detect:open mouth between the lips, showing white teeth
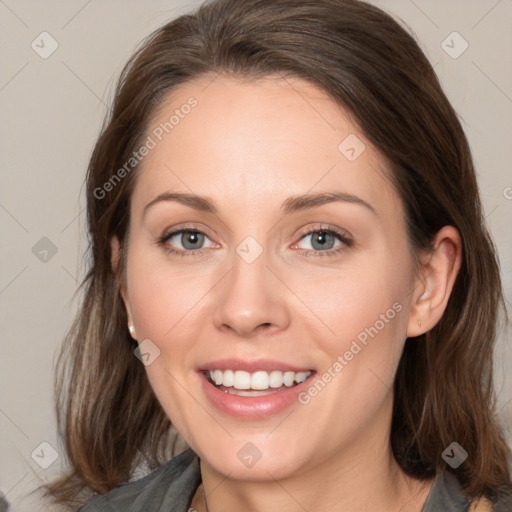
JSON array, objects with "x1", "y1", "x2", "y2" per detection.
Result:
[{"x1": 204, "y1": 370, "x2": 315, "y2": 397}]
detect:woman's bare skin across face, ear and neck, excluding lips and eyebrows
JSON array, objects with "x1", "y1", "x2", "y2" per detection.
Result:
[{"x1": 112, "y1": 76, "x2": 461, "y2": 512}]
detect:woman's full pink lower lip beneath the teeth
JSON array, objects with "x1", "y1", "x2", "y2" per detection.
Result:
[{"x1": 198, "y1": 371, "x2": 314, "y2": 419}]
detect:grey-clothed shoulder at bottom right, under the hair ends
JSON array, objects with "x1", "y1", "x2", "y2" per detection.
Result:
[{"x1": 422, "y1": 471, "x2": 512, "y2": 512}]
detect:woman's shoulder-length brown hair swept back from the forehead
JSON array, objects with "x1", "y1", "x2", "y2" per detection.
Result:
[{"x1": 47, "y1": 0, "x2": 512, "y2": 506}]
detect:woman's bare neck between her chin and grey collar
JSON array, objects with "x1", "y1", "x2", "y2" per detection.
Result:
[{"x1": 196, "y1": 434, "x2": 432, "y2": 512}]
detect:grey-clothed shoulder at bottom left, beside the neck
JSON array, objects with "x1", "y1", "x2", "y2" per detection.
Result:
[{"x1": 77, "y1": 449, "x2": 201, "y2": 512}]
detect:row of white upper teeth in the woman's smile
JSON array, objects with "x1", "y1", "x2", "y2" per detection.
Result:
[{"x1": 205, "y1": 370, "x2": 311, "y2": 391}]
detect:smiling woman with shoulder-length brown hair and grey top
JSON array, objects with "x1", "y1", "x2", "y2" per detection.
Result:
[{"x1": 43, "y1": 0, "x2": 512, "y2": 512}]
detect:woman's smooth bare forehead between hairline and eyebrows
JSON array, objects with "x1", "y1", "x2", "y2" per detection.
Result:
[{"x1": 133, "y1": 75, "x2": 398, "y2": 220}]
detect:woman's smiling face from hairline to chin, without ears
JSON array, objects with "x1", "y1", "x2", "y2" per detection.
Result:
[{"x1": 123, "y1": 77, "x2": 415, "y2": 480}]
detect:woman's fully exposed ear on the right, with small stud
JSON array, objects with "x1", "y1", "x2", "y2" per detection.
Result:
[{"x1": 407, "y1": 226, "x2": 462, "y2": 337}]
